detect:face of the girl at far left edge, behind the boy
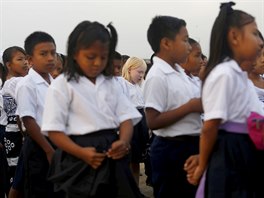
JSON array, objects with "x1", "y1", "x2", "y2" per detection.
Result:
[{"x1": 8, "y1": 51, "x2": 29, "y2": 76}]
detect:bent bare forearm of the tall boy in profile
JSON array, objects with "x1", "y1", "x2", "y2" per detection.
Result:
[{"x1": 146, "y1": 98, "x2": 202, "y2": 130}]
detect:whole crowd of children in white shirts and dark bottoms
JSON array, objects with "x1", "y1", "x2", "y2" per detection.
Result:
[{"x1": 0, "y1": 2, "x2": 264, "y2": 198}]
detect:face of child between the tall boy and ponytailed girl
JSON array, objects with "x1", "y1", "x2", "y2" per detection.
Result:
[{"x1": 186, "y1": 43, "x2": 203, "y2": 76}]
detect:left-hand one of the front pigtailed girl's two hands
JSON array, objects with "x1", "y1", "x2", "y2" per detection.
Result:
[{"x1": 81, "y1": 147, "x2": 106, "y2": 169}]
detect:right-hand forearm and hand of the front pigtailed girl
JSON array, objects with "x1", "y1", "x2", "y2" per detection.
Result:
[{"x1": 107, "y1": 120, "x2": 133, "y2": 159}]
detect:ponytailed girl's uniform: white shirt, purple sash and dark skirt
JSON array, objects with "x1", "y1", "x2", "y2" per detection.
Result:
[{"x1": 199, "y1": 59, "x2": 263, "y2": 198}]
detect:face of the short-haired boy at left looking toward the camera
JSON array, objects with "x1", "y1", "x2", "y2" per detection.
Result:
[{"x1": 28, "y1": 42, "x2": 56, "y2": 74}]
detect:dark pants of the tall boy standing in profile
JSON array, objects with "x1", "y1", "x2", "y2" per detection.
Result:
[{"x1": 150, "y1": 136, "x2": 199, "y2": 198}]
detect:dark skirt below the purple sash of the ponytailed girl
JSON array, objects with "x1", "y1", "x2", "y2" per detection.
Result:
[{"x1": 205, "y1": 130, "x2": 258, "y2": 198}]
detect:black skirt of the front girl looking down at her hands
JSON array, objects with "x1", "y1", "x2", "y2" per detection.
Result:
[{"x1": 49, "y1": 130, "x2": 142, "y2": 198}]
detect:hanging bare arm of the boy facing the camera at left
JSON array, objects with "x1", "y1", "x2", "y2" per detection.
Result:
[{"x1": 22, "y1": 116, "x2": 54, "y2": 162}]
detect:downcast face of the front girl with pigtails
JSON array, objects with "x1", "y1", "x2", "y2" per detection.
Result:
[{"x1": 74, "y1": 41, "x2": 109, "y2": 83}]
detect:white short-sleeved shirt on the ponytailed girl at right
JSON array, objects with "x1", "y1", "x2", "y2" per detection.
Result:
[{"x1": 202, "y1": 60, "x2": 263, "y2": 123}]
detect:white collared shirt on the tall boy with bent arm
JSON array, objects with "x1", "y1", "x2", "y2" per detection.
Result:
[{"x1": 143, "y1": 57, "x2": 202, "y2": 137}]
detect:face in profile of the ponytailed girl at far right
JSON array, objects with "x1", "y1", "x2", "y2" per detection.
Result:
[{"x1": 235, "y1": 22, "x2": 263, "y2": 62}]
